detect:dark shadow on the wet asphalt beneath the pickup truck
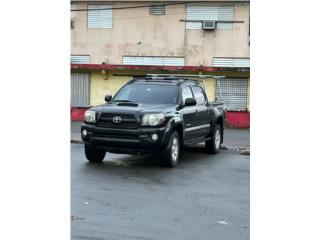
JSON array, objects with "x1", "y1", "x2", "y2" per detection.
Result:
[{"x1": 77, "y1": 146, "x2": 225, "y2": 185}]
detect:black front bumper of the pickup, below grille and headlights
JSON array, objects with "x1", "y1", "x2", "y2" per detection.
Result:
[{"x1": 81, "y1": 123, "x2": 169, "y2": 154}]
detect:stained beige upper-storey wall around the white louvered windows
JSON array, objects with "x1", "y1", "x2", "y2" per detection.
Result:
[{"x1": 71, "y1": 2, "x2": 249, "y2": 66}]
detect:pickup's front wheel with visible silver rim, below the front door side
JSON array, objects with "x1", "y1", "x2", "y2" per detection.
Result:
[{"x1": 161, "y1": 131, "x2": 181, "y2": 168}]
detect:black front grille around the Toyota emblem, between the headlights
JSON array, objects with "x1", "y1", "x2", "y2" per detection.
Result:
[{"x1": 97, "y1": 113, "x2": 138, "y2": 129}]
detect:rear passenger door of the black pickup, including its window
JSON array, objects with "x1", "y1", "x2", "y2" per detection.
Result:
[{"x1": 192, "y1": 86, "x2": 210, "y2": 137}]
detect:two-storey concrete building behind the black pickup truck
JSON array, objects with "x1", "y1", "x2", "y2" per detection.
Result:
[{"x1": 71, "y1": 0, "x2": 250, "y2": 127}]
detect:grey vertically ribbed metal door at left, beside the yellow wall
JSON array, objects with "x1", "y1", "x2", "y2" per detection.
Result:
[{"x1": 71, "y1": 73, "x2": 90, "y2": 107}]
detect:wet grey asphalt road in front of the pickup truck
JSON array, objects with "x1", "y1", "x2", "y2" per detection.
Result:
[{"x1": 71, "y1": 144, "x2": 250, "y2": 240}]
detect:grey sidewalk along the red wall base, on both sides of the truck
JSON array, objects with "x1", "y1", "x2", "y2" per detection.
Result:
[{"x1": 71, "y1": 121, "x2": 250, "y2": 149}]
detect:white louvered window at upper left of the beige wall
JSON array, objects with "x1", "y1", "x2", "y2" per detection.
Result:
[{"x1": 88, "y1": 5, "x2": 112, "y2": 28}]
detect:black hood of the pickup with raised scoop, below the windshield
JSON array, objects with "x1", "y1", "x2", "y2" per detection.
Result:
[{"x1": 90, "y1": 103, "x2": 178, "y2": 115}]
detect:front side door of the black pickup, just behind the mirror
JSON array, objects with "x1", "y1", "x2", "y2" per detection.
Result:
[{"x1": 181, "y1": 86, "x2": 197, "y2": 140}]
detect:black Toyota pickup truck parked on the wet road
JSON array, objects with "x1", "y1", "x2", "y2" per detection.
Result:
[{"x1": 81, "y1": 77, "x2": 225, "y2": 167}]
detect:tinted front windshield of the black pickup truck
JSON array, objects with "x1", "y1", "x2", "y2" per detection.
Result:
[{"x1": 113, "y1": 83, "x2": 178, "y2": 104}]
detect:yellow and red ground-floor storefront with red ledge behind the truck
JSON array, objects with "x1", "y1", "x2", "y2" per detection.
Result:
[{"x1": 71, "y1": 64, "x2": 250, "y2": 128}]
